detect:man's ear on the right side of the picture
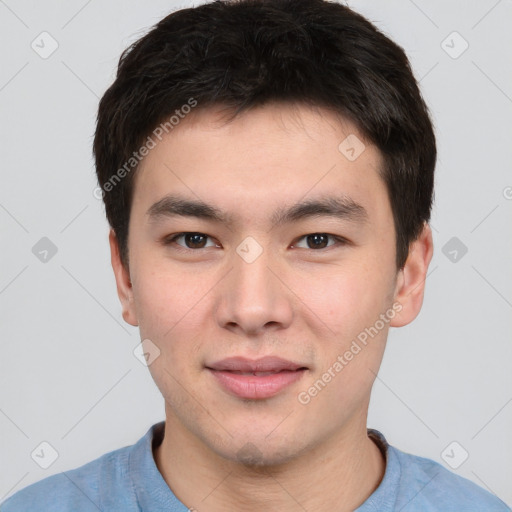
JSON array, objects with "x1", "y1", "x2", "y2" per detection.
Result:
[{"x1": 390, "y1": 223, "x2": 433, "y2": 327}]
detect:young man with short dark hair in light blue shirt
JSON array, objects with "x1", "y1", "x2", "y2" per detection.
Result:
[{"x1": 2, "y1": 0, "x2": 509, "y2": 512}]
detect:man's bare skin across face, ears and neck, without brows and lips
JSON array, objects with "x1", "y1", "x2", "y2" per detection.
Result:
[{"x1": 110, "y1": 104, "x2": 432, "y2": 512}]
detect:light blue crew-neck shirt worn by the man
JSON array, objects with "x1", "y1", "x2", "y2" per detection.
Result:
[{"x1": 0, "y1": 422, "x2": 511, "y2": 512}]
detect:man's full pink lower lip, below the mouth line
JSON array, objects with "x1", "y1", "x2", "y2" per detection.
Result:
[{"x1": 209, "y1": 368, "x2": 306, "y2": 400}]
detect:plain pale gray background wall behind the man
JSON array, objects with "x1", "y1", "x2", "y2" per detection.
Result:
[{"x1": 0, "y1": 0, "x2": 512, "y2": 505}]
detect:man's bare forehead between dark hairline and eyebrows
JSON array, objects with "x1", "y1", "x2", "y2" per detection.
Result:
[{"x1": 129, "y1": 104, "x2": 387, "y2": 226}]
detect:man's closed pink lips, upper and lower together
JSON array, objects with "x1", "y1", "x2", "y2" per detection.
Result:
[{"x1": 206, "y1": 356, "x2": 307, "y2": 400}]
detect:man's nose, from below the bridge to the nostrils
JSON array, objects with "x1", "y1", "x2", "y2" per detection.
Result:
[{"x1": 216, "y1": 242, "x2": 294, "y2": 337}]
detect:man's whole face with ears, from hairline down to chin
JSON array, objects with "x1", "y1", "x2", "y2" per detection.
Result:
[{"x1": 111, "y1": 105, "x2": 430, "y2": 464}]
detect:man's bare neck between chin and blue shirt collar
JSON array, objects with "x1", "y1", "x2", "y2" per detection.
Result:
[{"x1": 154, "y1": 415, "x2": 386, "y2": 512}]
